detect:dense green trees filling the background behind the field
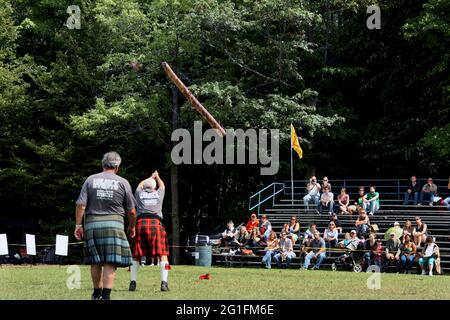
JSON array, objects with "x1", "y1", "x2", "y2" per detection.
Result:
[{"x1": 0, "y1": 0, "x2": 450, "y2": 255}]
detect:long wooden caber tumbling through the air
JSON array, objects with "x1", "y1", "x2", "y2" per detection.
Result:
[{"x1": 161, "y1": 62, "x2": 226, "y2": 137}]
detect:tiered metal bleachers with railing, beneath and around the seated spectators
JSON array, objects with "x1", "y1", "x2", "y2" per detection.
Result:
[{"x1": 213, "y1": 179, "x2": 450, "y2": 273}]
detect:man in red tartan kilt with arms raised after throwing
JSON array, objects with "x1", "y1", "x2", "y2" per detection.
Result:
[{"x1": 129, "y1": 171, "x2": 170, "y2": 291}]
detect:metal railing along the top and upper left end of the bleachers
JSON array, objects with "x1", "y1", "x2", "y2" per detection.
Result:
[{"x1": 249, "y1": 178, "x2": 450, "y2": 214}]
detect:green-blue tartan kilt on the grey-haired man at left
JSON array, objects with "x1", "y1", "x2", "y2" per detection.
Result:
[{"x1": 84, "y1": 215, "x2": 132, "y2": 267}]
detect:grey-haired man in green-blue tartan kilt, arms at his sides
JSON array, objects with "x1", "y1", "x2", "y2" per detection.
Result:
[{"x1": 74, "y1": 152, "x2": 136, "y2": 300}]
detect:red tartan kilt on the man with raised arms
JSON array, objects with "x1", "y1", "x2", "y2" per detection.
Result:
[{"x1": 132, "y1": 218, "x2": 169, "y2": 261}]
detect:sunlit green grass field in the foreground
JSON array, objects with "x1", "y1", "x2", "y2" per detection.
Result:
[{"x1": 0, "y1": 266, "x2": 450, "y2": 300}]
